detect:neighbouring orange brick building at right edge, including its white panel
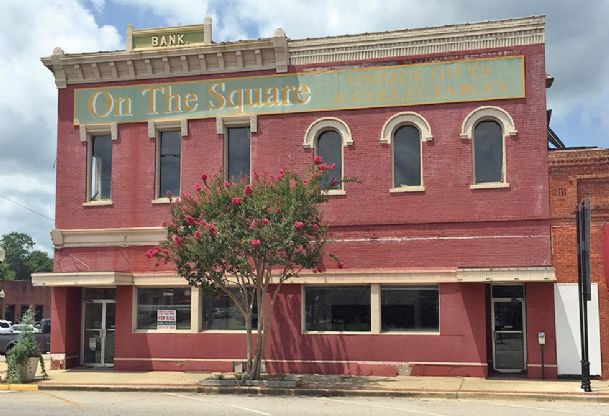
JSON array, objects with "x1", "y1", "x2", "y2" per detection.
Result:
[{"x1": 549, "y1": 148, "x2": 609, "y2": 377}]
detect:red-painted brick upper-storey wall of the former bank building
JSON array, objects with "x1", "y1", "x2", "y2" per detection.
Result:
[{"x1": 55, "y1": 44, "x2": 550, "y2": 272}]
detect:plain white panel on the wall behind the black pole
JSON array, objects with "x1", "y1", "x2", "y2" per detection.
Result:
[{"x1": 554, "y1": 283, "x2": 601, "y2": 376}]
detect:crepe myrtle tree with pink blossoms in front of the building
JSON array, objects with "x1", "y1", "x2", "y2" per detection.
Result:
[{"x1": 147, "y1": 157, "x2": 344, "y2": 380}]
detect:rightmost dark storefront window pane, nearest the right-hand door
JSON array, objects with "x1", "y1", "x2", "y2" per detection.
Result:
[{"x1": 381, "y1": 286, "x2": 439, "y2": 331}]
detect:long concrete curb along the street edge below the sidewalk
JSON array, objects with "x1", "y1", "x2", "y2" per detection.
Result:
[{"x1": 35, "y1": 384, "x2": 609, "y2": 403}]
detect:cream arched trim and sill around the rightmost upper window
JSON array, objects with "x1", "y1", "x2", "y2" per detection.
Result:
[{"x1": 461, "y1": 106, "x2": 518, "y2": 190}]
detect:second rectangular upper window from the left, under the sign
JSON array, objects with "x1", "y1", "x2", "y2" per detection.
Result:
[{"x1": 156, "y1": 130, "x2": 182, "y2": 198}]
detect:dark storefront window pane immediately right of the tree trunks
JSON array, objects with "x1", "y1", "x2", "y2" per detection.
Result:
[{"x1": 305, "y1": 286, "x2": 370, "y2": 331}]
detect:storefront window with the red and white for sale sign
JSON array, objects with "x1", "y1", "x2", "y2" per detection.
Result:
[{"x1": 137, "y1": 288, "x2": 190, "y2": 329}]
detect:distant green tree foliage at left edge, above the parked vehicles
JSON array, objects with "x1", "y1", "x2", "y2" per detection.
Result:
[{"x1": 0, "y1": 232, "x2": 53, "y2": 280}]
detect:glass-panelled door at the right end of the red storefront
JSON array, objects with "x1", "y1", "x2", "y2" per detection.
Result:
[{"x1": 491, "y1": 285, "x2": 526, "y2": 373}]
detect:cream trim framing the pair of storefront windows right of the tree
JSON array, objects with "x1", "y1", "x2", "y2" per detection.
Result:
[{"x1": 300, "y1": 283, "x2": 442, "y2": 336}]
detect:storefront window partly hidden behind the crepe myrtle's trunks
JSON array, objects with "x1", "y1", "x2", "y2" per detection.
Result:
[{"x1": 203, "y1": 288, "x2": 258, "y2": 330}]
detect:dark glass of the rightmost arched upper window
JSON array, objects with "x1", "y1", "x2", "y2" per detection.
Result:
[{"x1": 473, "y1": 120, "x2": 505, "y2": 184}]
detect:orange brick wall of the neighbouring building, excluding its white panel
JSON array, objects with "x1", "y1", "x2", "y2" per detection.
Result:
[{"x1": 549, "y1": 149, "x2": 609, "y2": 378}]
